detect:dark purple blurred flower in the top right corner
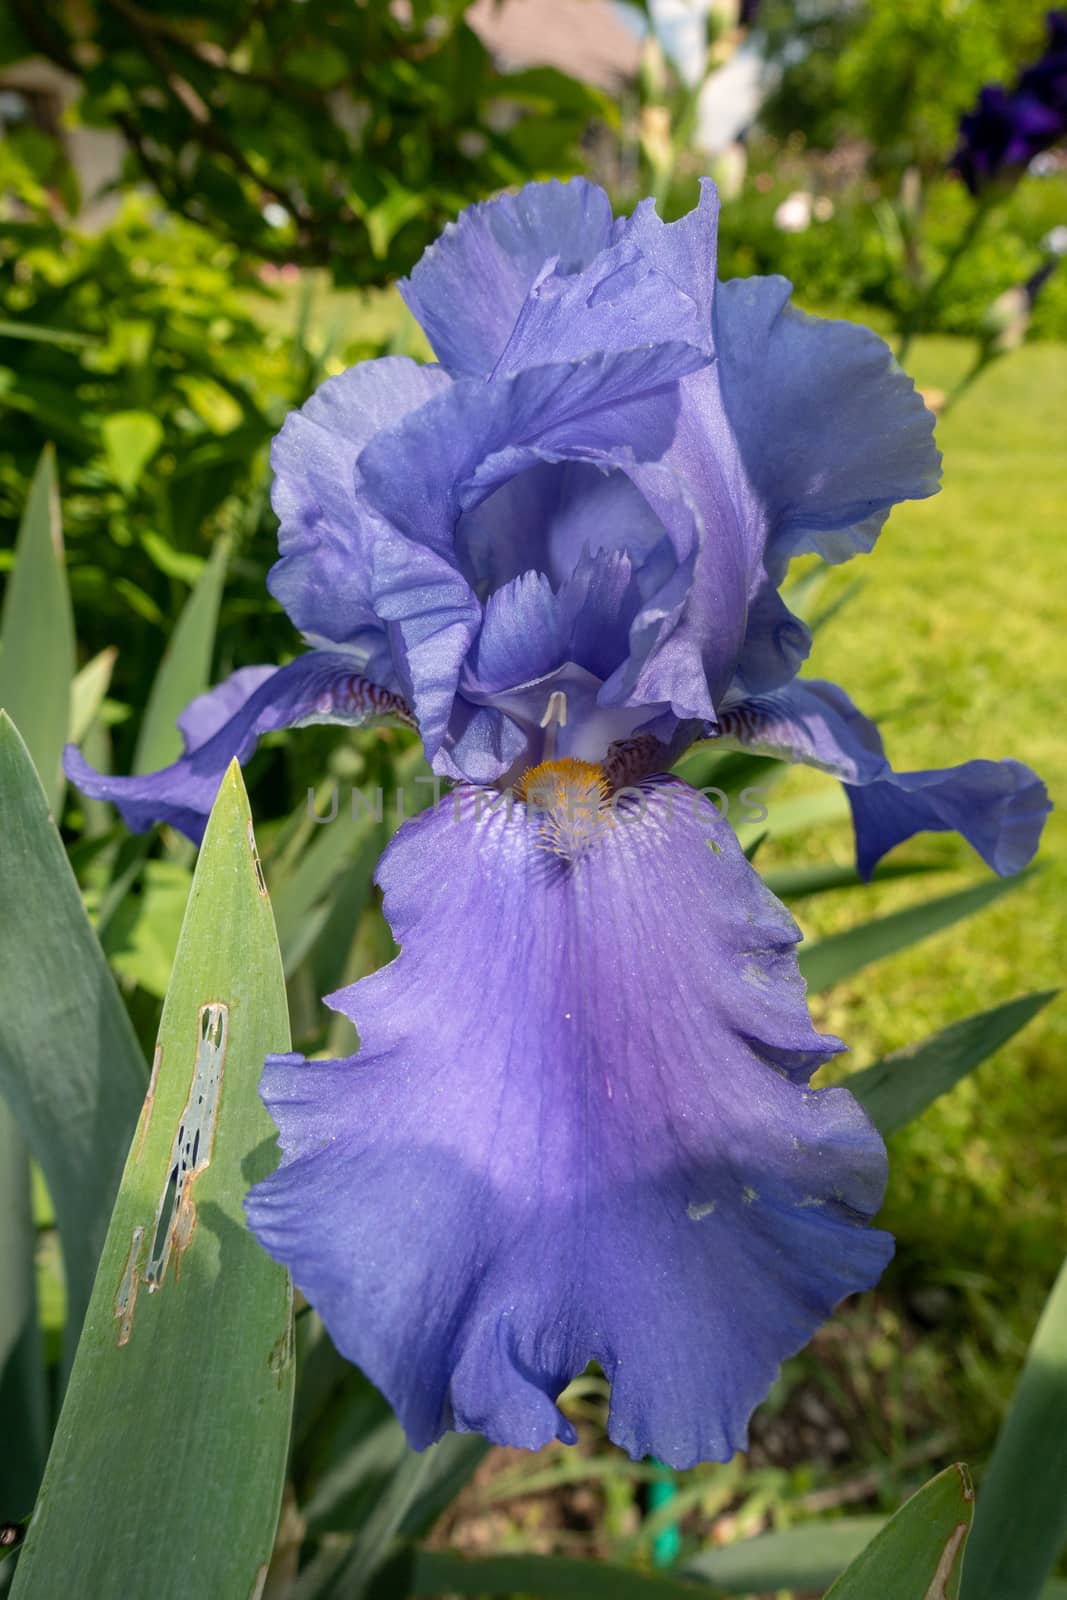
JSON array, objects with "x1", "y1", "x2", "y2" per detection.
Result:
[{"x1": 952, "y1": 11, "x2": 1067, "y2": 195}]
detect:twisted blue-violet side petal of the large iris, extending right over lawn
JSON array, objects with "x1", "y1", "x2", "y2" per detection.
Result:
[{"x1": 718, "y1": 678, "x2": 1051, "y2": 878}]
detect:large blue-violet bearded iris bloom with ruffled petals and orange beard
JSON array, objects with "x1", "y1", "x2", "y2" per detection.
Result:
[{"x1": 67, "y1": 181, "x2": 1048, "y2": 1467}]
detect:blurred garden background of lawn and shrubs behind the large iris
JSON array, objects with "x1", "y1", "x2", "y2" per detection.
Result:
[{"x1": 0, "y1": 0, "x2": 1067, "y2": 1587}]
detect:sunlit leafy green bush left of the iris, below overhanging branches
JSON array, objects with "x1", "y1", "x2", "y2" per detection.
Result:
[{"x1": 0, "y1": 197, "x2": 300, "y2": 729}]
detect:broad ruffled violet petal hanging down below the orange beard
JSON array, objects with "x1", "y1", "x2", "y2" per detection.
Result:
[{"x1": 246, "y1": 779, "x2": 891, "y2": 1467}]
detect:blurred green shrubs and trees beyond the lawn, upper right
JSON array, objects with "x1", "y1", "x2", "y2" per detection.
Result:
[{"x1": 627, "y1": 0, "x2": 1067, "y2": 344}]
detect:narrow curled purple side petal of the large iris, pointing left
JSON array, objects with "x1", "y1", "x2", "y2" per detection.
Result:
[{"x1": 62, "y1": 650, "x2": 410, "y2": 843}]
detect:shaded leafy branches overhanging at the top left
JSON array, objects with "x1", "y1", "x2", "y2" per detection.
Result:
[{"x1": 0, "y1": 0, "x2": 613, "y2": 283}]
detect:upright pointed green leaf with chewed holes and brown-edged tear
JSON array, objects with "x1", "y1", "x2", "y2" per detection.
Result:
[{"x1": 13, "y1": 765, "x2": 293, "y2": 1600}]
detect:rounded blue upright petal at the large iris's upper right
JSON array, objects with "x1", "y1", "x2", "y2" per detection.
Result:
[{"x1": 709, "y1": 278, "x2": 941, "y2": 584}]
